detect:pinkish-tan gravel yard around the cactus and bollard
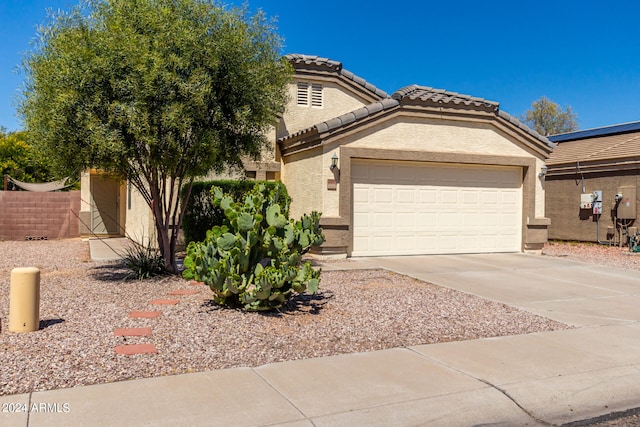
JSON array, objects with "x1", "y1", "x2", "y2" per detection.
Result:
[{"x1": 0, "y1": 239, "x2": 567, "y2": 395}]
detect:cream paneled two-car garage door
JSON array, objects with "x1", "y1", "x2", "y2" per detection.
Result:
[{"x1": 351, "y1": 160, "x2": 522, "y2": 256}]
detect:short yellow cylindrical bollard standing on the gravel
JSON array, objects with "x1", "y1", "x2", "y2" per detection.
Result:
[{"x1": 9, "y1": 267, "x2": 40, "y2": 332}]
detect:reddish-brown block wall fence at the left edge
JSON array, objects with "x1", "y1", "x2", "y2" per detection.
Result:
[{"x1": 0, "y1": 191, "x2": 80, "y2": 240}]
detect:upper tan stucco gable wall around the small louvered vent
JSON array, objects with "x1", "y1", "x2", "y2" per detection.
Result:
[{"x1": 277, "y1": 78, "x2": 368, "y2": 138}]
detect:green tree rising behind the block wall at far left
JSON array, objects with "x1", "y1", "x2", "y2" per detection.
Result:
[{"x1": 0, "y1": 127, "x2": 53, "y2": 186}]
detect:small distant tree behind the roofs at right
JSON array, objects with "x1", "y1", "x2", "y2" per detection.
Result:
[{"x1": 522, "y1": 96, "x2": 578, "y2": 136}]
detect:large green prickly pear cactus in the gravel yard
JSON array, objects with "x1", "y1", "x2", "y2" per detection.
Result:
[{"x1": 183, "y1": 184, "x2": 324, "y2": 311}]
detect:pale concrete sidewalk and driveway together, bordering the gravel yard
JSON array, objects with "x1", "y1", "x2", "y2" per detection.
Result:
[{"x1": 0, "y1": 254, "x2": 640, "y2": 426}]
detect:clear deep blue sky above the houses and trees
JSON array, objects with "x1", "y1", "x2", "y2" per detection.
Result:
[{"x1": 0, "y1": 0, "x2": 640, "y2": 130}]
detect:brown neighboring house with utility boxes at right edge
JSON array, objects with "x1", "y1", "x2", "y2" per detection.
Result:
[{"x1": 545, "y1": 122, "x2": 640, "y2": 243}]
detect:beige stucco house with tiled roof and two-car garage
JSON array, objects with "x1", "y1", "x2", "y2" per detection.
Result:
[{"x1": 84, "y1": 54, "x2": 553, "y2": 256}]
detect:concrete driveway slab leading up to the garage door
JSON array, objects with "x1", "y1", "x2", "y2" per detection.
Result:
[{"x1": 353, "y1": 253, "x2": 640, "y2": 327}]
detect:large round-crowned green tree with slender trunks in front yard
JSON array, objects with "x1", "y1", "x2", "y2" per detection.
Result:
[{"x1": 20, "y1": 0, "x2": 291, "y2": 272}]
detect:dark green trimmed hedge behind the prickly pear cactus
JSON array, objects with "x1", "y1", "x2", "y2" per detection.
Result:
[{"x1": 182, "y1": 180, "x2": 291, "y2": 245}]
